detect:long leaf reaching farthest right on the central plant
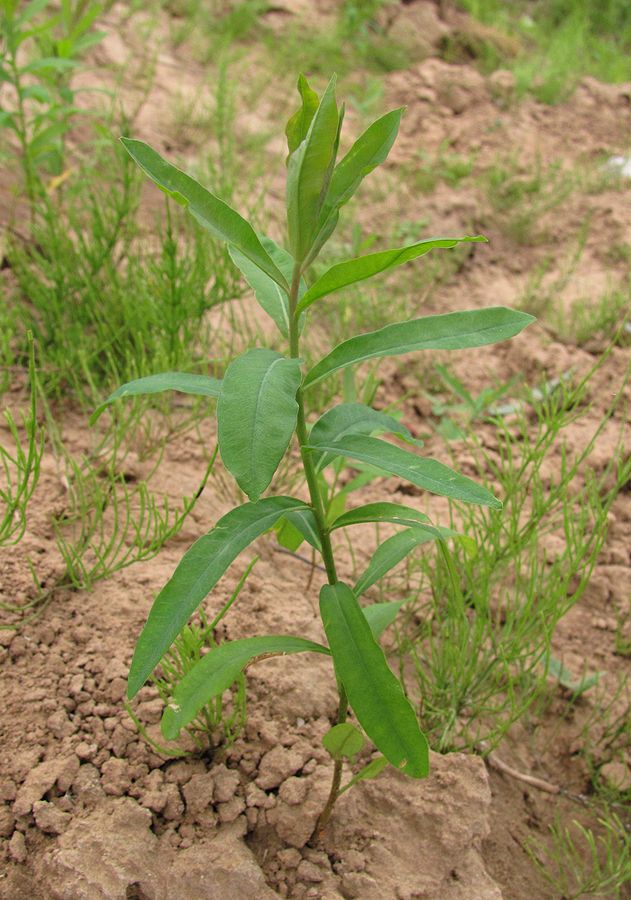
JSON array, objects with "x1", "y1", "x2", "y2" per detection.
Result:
[{"x1": 303, "y1": 306, "x2": 535, "y2": 388}]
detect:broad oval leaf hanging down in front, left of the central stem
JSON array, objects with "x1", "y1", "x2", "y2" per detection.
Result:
[{"x1": 217, "y1": 348, "x2": 301, "y2": 500}]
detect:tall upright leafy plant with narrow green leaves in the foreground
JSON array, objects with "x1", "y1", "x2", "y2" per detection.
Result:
[{"x1": 96, "y1": 77, "x2": 532, "y2": 828}]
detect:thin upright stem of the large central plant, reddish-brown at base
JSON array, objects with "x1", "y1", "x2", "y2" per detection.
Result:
[{"x1": 289, "y1": 263, "x2": 348, "y2": 838}]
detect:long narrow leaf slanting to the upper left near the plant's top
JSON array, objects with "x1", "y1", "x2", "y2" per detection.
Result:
[{"x1": 121, "y1": 138, "x2": 289, "y2": 290}]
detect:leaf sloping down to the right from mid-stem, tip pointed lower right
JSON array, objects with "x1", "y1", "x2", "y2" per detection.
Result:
[{"x1": 308, "y1": 434, "x2": 502, "y2": 509}]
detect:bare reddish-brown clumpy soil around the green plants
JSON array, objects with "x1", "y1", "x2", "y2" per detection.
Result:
[{"x1": 0, "y1": 4, "x2": 631, "y2": 900}]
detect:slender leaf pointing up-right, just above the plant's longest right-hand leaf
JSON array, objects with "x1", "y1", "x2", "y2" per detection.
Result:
[{"x1": 297, "y1": 235, "x2": 486, "y2": 312}]
